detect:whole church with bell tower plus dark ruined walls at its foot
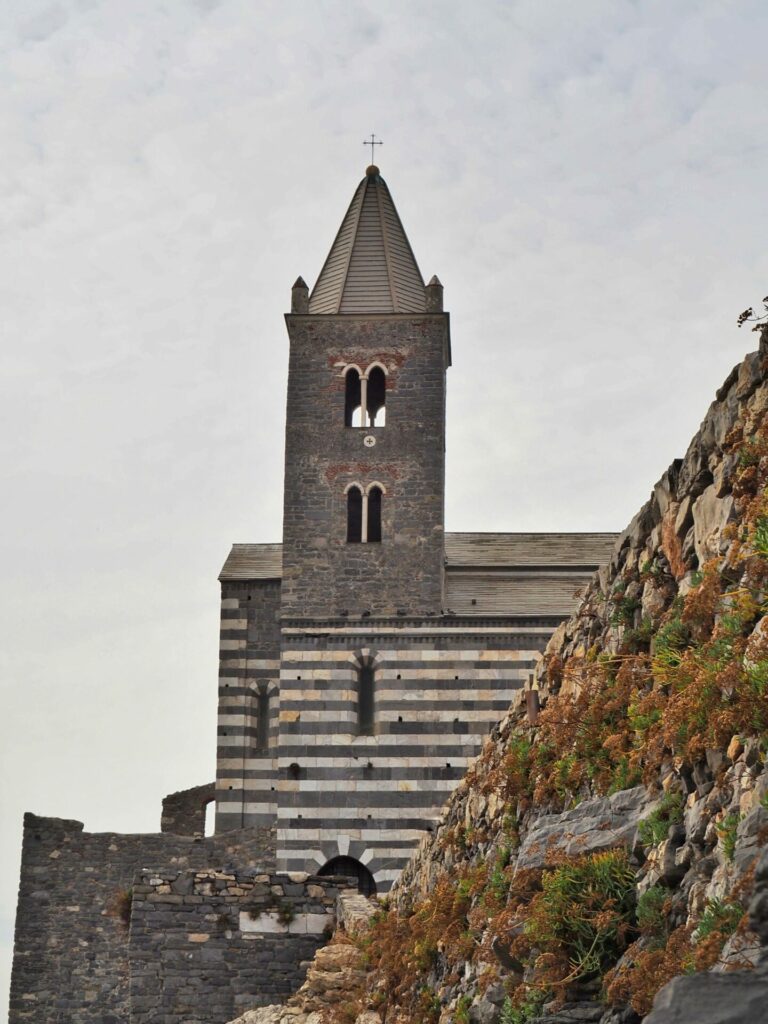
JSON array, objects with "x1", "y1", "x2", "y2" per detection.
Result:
[{"x1": 9, "y1": 166, "x2": 615, "y2": 1024}]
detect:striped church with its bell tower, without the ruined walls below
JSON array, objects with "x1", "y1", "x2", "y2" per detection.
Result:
[{"x1": 211, "y1": 166, "x2": 614, "y2": 892}]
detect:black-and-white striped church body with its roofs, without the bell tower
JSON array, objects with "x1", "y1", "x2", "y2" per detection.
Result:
[{"x1": 211, "y1": 534, "x2": 613, "y2": 892}]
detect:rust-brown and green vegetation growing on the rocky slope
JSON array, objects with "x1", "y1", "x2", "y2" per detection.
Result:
[{"x1": 339, "y1": 399, "x2": 768, "y2": 1024}]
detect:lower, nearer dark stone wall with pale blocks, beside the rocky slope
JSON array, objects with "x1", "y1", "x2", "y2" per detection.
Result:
[{"x1": 130, "y1": 870, "x2": 356, "y2": 1024}]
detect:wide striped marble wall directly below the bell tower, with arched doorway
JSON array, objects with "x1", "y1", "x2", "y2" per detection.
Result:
[{"x1": 278, "y1": 621, "x2": 552, "y2": 891}]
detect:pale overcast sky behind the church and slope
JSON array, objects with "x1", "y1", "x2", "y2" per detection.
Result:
[{"x1": 0, "y1": 0, "x2": 768, "y2": 1005}]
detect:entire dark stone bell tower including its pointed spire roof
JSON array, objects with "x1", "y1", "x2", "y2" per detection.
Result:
[{"x1": 282, "y1": 166, "x2": 451, "y2": 618}]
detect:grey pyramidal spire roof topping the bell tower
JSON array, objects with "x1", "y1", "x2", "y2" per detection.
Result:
[{"x1": 309, "y1": 166, "x2": 426, "y2": 313}]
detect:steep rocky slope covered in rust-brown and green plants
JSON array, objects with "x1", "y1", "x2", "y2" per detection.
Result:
[{"x1": 230, "y1": 332, "x2": 768, "y2": 1024}]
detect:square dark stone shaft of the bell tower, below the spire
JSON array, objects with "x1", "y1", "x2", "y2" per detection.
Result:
[{"x1": 283, "y1": 313, "x2": 447, "y2": 616}]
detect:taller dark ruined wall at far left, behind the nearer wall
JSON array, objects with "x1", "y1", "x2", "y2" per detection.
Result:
[{"x1": 9, "y1": 814, "x2": 273, "y2": 1024}]
